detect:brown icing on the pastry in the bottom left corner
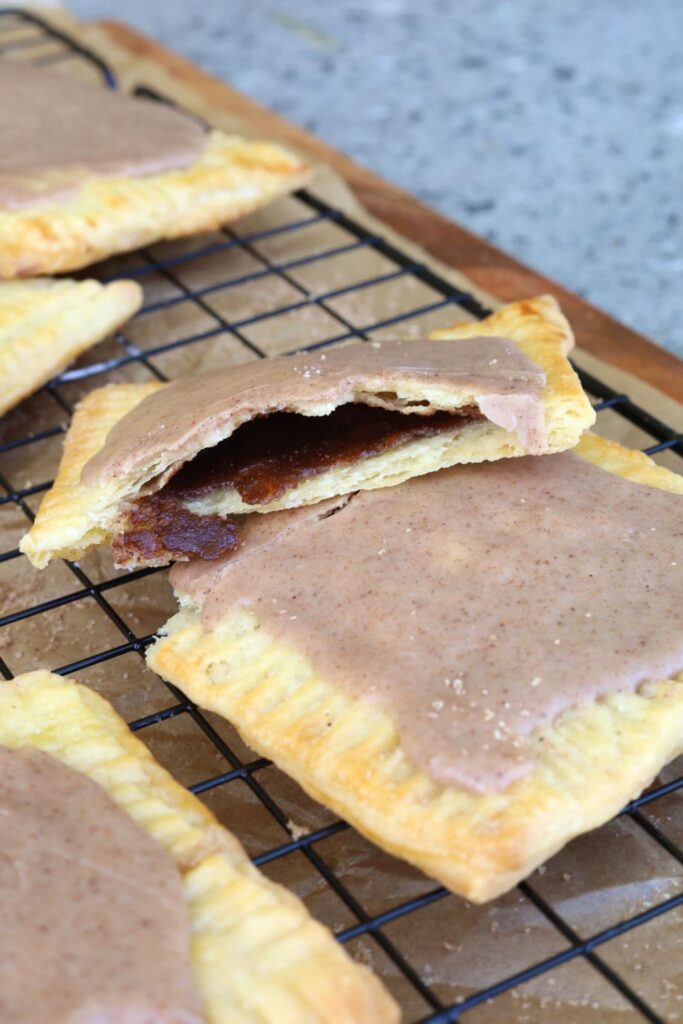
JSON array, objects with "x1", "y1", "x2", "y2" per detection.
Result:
[{"x1": 0, "y1": 746, "x2": 204, "y2": 1024}]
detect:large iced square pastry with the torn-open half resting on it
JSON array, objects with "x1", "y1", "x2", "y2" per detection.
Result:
[{"x1": 147, "y1": 434, "x2": 683, "y2": 902}]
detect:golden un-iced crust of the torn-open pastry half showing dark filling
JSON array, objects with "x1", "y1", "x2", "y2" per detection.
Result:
[{"x1": 22, "y1": 296, "x2": 595, "y2": 568}]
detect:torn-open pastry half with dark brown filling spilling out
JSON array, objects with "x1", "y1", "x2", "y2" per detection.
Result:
[{"x1": 22, "y1": 297, "x2": 595, "y2": 567}]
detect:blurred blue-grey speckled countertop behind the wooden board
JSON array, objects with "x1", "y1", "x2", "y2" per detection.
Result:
[{"x1": 69, "y1": 0, "x2": 683, "y2": 354}]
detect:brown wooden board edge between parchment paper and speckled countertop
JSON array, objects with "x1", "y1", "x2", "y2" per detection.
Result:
[{"x1": 98, "y1": 20, "x2": 683, "y2": 401}]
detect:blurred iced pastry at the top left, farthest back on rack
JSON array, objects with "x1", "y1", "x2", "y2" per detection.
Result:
[{"x1": 0, "y1": 60, "x2": 309, "y2": 278}]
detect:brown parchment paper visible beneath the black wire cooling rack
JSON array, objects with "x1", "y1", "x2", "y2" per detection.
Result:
[{"x1": 0, "y1": 10, "x2": 683, "y2": 1024}]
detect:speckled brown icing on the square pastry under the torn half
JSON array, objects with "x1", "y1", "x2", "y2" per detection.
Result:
[{"x1": 173, "y1": 453, "x2": 683, "y2": 791}]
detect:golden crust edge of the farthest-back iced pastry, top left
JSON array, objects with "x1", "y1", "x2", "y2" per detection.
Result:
[{"x1": 0, "y1": 131, "x2": 310, "y2": 279}]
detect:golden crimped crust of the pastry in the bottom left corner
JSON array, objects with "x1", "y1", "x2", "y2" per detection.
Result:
[{"x1": 0, "y1": 672, "x2": 399, "y2": 1024}]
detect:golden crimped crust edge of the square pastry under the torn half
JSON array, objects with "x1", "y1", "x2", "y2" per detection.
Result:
[{"x1": 147, "y1": 436, "x2": 683, "y2": 902}]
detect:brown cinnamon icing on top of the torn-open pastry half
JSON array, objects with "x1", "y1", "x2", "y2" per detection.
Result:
[{"x1": 81, "y1": 337, "x2": 546, "y2": 485}]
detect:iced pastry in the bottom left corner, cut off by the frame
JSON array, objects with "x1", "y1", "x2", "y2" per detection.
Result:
[{"x1": 0, "y1": 672, "x2": 399, "y2": 1024}]
